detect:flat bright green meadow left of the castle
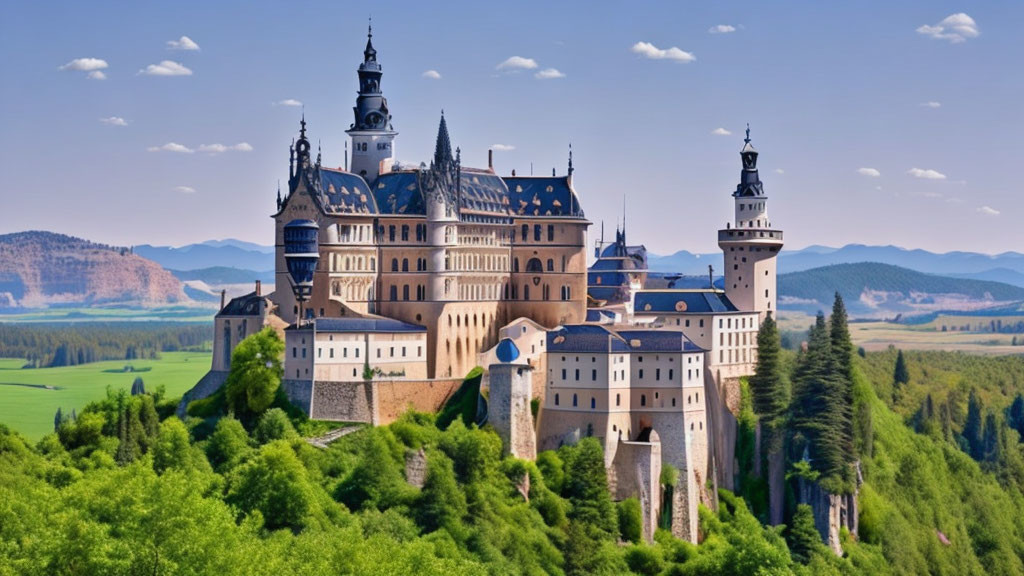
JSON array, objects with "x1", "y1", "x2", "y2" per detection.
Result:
[{"x1": 0, "y1": 352, "x2": 211, "y2": 440}]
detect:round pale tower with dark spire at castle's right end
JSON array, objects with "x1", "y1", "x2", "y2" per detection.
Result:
[{"x1": 718, "y1": 126, "x2": 782, "y2": 320}]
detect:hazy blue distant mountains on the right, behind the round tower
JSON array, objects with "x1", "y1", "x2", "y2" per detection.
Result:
[{"x1": 648, "y1": 244, "x2": 1024, "y2": 287}]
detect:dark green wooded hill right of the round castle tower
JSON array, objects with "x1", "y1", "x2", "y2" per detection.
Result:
[{"x1": 778, "y1": 262, "x2": 1024, "y2": 316}]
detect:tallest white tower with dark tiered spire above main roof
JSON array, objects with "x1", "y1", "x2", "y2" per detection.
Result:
[{"x1": 345, "y1": 21, "x2": 398, "y2": 182}]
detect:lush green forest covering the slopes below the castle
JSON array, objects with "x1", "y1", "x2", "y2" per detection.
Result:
[{"x1": 0, "y1": 317, "x2": 1024, "y2": 575}]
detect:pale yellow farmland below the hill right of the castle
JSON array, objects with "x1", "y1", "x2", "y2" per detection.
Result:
[{"x1": 779, "y1": 313, "x2": 1024, "y2": 356}]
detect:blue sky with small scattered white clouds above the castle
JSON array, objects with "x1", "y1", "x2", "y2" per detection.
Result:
[{"x1": 0, "y1": 1, "x2": 1024, "y2": 253}]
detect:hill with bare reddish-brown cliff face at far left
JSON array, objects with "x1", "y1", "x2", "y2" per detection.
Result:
[{"x1": 0, "y1": 232, "x2": 188, "y2": 311}]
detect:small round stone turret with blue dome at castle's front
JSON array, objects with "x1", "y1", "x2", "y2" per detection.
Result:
[{"x1": 487, "y1": 338, "x2": 537, "y2": 460}]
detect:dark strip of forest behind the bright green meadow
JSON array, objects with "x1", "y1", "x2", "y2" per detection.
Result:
[{"x1": 0, "y1": 322, "x2": 213, "y2": 368}]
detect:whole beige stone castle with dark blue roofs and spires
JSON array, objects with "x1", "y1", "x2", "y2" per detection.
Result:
[{"x1": 182, "y1": 25, "x2": 782, "y2": 540}]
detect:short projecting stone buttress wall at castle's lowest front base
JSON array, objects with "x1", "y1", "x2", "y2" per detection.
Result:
[{"x1": 608, "y1": 430, "x2": 662, "y2": 542}]
